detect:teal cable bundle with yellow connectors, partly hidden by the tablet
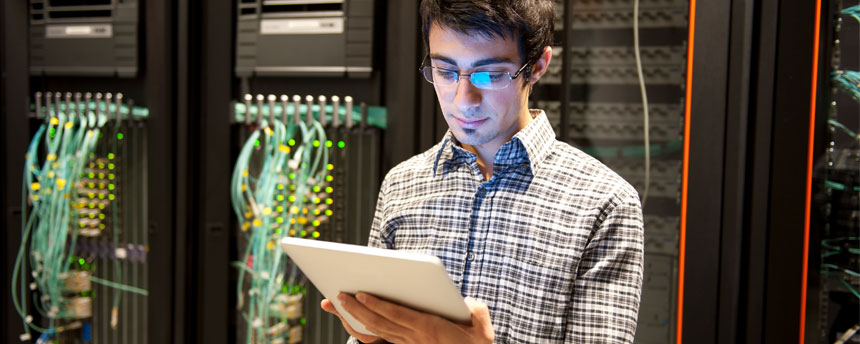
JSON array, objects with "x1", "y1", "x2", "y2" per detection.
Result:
[{"x1": 230, "y1": 94, "x2": 352, "y2": 343}]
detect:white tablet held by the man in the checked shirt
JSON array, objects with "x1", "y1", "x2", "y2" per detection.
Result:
[{"x1": 281, "y1": 238, "x2": 472, "y2": 335}]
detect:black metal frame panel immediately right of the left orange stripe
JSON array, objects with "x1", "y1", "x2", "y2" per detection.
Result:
[{"x1": 682, "y1": 1, "x2": 735, "y2": 342}]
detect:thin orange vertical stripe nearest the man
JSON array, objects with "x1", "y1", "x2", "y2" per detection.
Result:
[{"x1": 675, "y1": 0, "x2": 696, "y2": 344}]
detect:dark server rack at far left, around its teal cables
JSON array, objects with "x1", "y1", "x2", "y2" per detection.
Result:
[{"x1": 0, "y1": 1, "x2": 185, "y2": 343}]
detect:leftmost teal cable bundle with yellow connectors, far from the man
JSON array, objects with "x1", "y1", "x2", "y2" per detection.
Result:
[{"x1": 12, "y1": 93, "x2": 146, "y2": 341}]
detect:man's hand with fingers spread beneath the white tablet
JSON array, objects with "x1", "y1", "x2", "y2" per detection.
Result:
[{"x1": 321, "y1": 293, "x2": 494, "y2": 344}]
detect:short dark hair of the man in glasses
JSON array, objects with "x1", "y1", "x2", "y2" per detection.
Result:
[{"x1": 421, "y1": 0, "x2": 555, "y2": 78}]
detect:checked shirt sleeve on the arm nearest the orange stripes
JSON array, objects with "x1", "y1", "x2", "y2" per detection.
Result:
[{"x1": 565, "y1": 191, "x2": 645, "y2": 343}]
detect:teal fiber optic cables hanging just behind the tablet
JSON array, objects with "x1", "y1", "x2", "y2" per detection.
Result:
[{"x1": 230, "y1": 97, "x2": 340, "y2": 343}]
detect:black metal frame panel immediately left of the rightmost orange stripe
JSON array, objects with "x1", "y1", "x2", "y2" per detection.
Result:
[{"x1": 740, "y1": 0, "x2": 826, "y2": 343}]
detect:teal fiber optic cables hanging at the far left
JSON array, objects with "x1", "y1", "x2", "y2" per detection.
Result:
[{"x1": 12, "y1": 93, "x2": 146, "y2": 338}]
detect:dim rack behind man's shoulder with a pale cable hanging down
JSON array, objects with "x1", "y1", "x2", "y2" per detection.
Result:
[{"x1": 530, "y1": 0, "x2": 689, "y2": 343}]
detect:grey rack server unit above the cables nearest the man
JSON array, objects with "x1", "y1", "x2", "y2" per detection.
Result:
[{"x1": 236, "y1": 0, "x2": 374, "y2": 78}]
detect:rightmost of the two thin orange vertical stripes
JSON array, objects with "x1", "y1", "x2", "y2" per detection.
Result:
[{"x1": 799, "y1": 0, "x2": 821, "y2": 344}]
